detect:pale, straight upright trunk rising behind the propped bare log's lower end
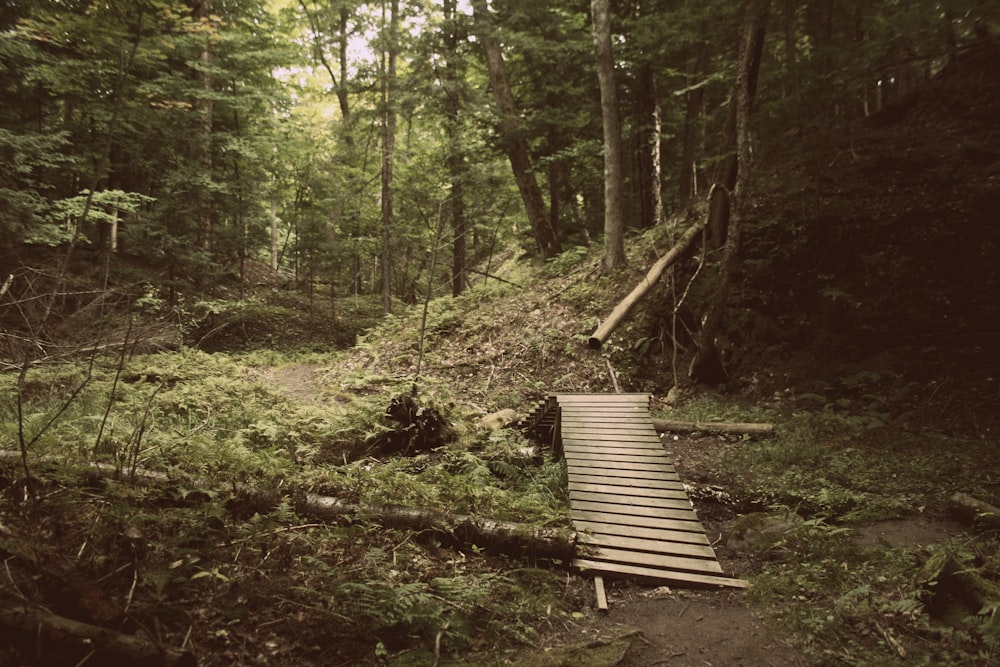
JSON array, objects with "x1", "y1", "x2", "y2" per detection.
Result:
[{"x1": 590, "y1": 0, "x2": 625, "y2": 271}]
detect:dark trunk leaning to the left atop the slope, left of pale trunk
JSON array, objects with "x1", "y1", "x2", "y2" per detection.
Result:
[{"x1": 472, "y1": 0, "x2": 562, "y2": 259}]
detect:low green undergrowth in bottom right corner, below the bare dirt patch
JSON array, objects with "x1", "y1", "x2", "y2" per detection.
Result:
[{"x1": 748, "y1": 518, "x2": 1000, "y2": 666}]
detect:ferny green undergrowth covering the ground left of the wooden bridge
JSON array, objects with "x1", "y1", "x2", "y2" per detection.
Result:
[{"x1": 0, "y1": 350, "x2": 573, "y2": 664}]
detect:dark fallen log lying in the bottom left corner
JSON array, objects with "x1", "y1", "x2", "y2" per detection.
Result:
[{"x1": 0, "y1": 602, "x2": 198, "y2": 667}]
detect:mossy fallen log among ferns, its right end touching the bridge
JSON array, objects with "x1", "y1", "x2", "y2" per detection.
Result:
[{"x1": 295, "y1": 494, "x2": 576, "y2": 562}]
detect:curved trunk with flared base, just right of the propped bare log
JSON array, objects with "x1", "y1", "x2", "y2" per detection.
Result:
[{"x1": 688, "y1": 0, "x2": 770, "y2": 384}]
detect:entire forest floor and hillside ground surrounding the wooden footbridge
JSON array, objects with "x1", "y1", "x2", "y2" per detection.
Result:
[{"x1": 0, "y1": 37, "x2": 1000, "y2": 667}]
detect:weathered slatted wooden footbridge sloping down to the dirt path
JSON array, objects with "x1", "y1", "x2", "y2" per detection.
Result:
[{"x1": 527, "y1": 394, "x2": 747, "y2": 597}]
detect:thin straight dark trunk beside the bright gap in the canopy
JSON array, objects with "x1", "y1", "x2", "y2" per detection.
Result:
[{"x1": 381, "y1": 0, "x2": 399, "y2": 313}]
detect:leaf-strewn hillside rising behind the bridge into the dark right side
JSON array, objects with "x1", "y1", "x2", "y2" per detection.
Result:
[{"x1": 331, "y1": 43, "x2": 1000, "y2": 438}]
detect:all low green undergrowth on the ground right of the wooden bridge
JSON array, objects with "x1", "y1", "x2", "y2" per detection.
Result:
[{"x1": 669, "y1": 392, "x2": 1000, "y2": 665}]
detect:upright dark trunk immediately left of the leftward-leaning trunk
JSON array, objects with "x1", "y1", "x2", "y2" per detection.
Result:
[{"x1": 444, "y1": 0, "x2": 468, "y2": 296}]
